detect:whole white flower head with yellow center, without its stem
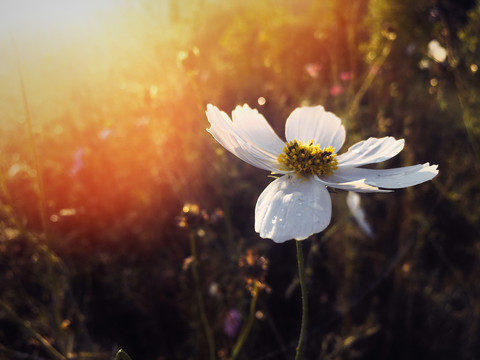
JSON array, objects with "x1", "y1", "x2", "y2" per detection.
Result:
[{"x1": 206, "y1": 105, "x2": 438, "y2": 243}]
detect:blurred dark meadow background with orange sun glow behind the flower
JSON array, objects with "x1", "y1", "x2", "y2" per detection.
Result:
[{"x1": 0, "y1": 0, "x2": 480, "y2": 360}]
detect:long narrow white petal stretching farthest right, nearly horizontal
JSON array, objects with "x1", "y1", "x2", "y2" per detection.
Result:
[{"x1": 334, "y1": 163, "x2": 438, "y2": 189}]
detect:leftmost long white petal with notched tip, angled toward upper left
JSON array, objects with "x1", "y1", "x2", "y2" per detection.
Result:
[{"x1": 206, "y1": 104, "x2": 285, "y2": 173}]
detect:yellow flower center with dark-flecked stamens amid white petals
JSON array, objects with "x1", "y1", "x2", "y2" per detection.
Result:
[{"x1": 278, "y1": 139, "x2": 338, "y2": 177}]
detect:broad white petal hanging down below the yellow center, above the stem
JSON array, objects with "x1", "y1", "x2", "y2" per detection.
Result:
[{"x1": 255, "y1": 174, "x2": 332, "y2": 243}]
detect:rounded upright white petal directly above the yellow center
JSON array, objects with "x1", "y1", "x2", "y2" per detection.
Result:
[{"x1": 285, "y1": 106, "x2": 345, "y2": 152}]
